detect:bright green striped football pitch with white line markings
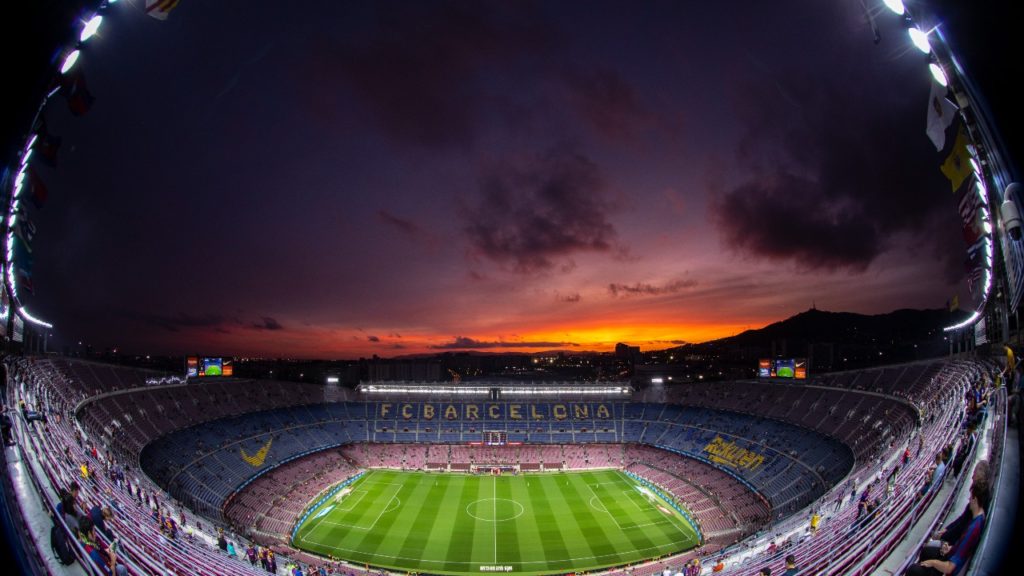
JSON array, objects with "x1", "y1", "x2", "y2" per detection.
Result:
[{"x1": 293, "y1": 470, "x2": 697, "y2": 574}]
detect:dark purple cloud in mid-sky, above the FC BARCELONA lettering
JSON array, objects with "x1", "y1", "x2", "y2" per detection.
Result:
[{"x1": 463, "y1": 151, "x2": 620, "y2": 274}]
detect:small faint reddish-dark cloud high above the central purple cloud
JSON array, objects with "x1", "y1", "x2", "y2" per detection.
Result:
[{"x1": 565, "y1": 69, "x2": 650, "y2": 139}]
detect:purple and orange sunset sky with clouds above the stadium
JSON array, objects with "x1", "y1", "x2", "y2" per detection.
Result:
[{"x1": 27, "y1": 0, "x2": 999, "y2": 358}]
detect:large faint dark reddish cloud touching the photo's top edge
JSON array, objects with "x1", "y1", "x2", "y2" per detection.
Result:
[{"x1": 329, "y1": 1, "x2": 552, "y2": 147}]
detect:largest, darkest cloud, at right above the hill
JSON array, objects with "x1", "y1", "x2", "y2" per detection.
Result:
[{"x1": 711, "y1": 50, "x2": 951, "y2": 272}]
